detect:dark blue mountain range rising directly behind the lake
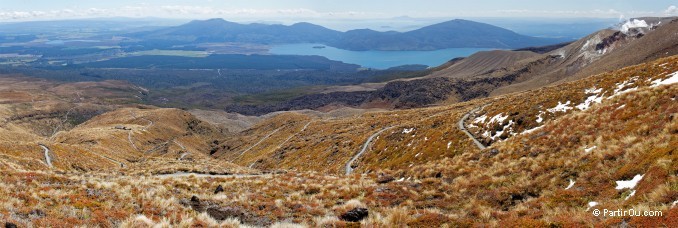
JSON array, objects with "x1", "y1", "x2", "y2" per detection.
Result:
[{"x1": 132, "y1": 19, "x2": 566, "y2": 51}]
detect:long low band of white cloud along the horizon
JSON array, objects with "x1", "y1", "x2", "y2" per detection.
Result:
[{"x1": 0, "y1": 3, "x2": 678, "y2": 21}]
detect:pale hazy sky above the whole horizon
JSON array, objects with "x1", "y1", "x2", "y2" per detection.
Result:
[{"x1": 0, "y1": 0, "x2": 678, "y2": 22}]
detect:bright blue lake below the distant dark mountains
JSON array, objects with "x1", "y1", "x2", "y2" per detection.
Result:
[{"x1": 269, "y1": 44, "x2": 491, "y2": 69}]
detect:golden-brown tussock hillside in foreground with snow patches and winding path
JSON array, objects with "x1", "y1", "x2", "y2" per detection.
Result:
[{"x1": 0, "y1": 56, "x2": 678, "y2": 227}]
